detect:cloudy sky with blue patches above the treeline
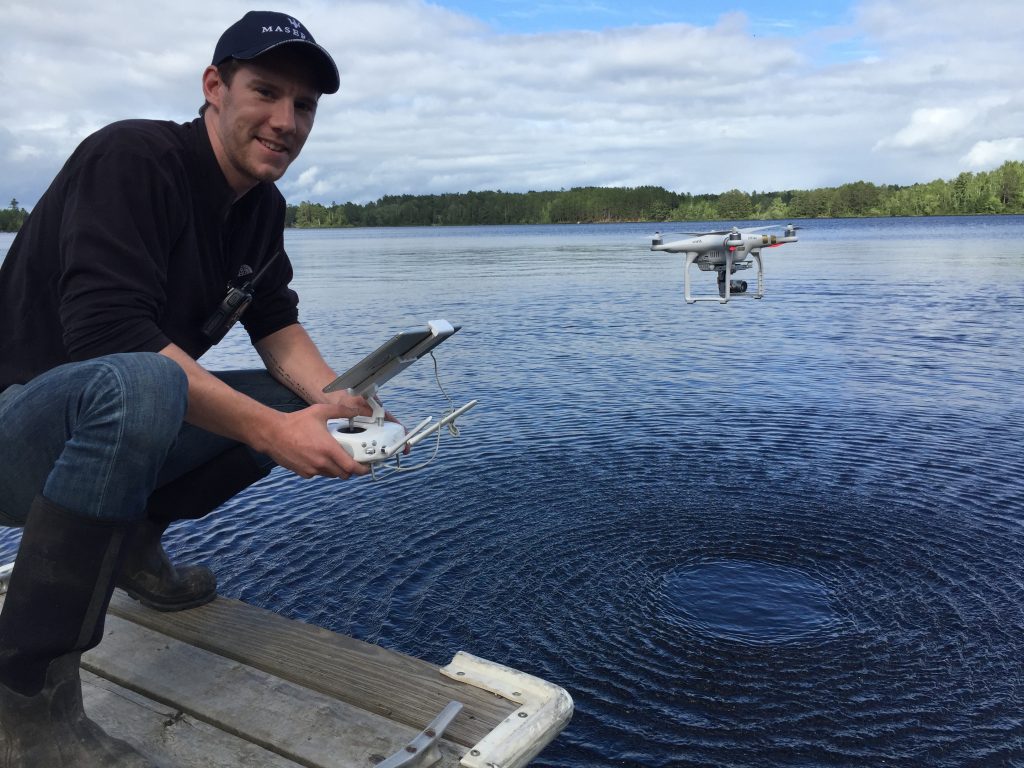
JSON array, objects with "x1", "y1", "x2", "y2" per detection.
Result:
[{"x1": 0, "y1": 0, "x2": 1024, "y2": 209}]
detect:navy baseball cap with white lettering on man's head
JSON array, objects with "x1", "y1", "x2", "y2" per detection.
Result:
[{"x1": 212, "y1": 10, "x2": 341, "y2": 93}]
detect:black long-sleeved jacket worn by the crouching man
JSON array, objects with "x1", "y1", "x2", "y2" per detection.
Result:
[{"x1": 0, "y1": 118, "x2": 298, "y2": 390}]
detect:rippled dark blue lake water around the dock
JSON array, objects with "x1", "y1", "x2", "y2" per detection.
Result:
[{"x1": 0, "y1": 217, "x2": 1024, "y2": 768}]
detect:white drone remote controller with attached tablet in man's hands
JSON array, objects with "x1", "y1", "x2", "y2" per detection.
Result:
[{"x1": 324, "y1": 319, "x2": 477, "y2": 478}]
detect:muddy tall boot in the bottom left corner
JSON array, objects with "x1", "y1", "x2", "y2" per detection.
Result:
[{"x1": 0, "y1": 496, "x2": 154, "y2": 768}]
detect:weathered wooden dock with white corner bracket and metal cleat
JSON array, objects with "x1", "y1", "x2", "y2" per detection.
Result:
[{"x1": 0, "y1": 574, "x2": 572, "y2": 768}]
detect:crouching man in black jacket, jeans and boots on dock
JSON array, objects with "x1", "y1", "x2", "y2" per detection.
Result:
[{"x1": 0, "y1": 11, "x2": 387, "y2": 768}]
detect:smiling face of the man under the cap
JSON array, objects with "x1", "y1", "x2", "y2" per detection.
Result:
[{"x1": 203, "y1": 46, "x2": 319, "y2": 197}]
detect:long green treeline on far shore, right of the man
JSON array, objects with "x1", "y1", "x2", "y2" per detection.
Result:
[{"x1": 287, "y1": 161, "x2": 1024, "y2": 227}]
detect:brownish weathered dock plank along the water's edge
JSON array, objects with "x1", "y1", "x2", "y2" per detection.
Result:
[{"x1": 104, "y1": 591, "x2": 516, "y2": 746}]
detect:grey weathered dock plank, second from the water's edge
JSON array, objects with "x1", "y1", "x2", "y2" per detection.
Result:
[{"x1": 82, "y1": 616, "x2": 465, "y2": 768}]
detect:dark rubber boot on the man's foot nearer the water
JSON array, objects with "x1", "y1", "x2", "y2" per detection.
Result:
[{"x1": 117, "y1": 445, "x2": 270, "y2": 611}]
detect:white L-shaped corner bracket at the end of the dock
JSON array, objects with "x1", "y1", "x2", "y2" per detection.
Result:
[{"x1": 441, "y1": 651, "x2": 572, "y2": 768}]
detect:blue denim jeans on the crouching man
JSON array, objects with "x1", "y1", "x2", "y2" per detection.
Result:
[{"x1": 0, "y1": 352, "x2": 306, "y2": 525}]
